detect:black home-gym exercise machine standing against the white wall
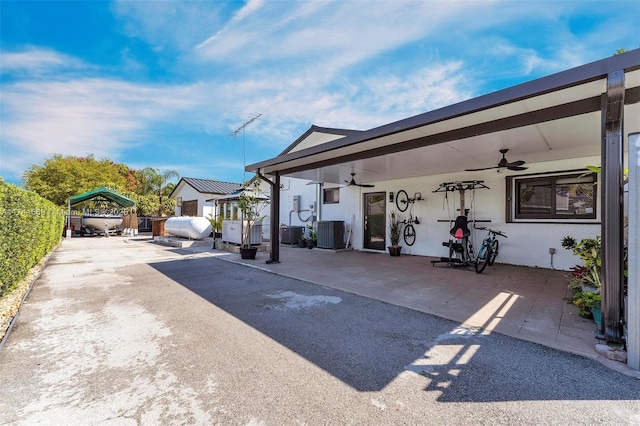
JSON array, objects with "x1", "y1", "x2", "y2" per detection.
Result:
[{"x1": 431, "y1": 180, "x2": 491, "y2": 266}]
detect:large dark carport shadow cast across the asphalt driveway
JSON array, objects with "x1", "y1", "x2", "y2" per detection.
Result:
[{"x1": 150, "y1": 257, "x2": 640, "y2": 402}]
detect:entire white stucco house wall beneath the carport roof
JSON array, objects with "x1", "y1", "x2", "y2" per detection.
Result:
[{"x1": 280, "y1": 157, "x2": 601, "y2": 270}]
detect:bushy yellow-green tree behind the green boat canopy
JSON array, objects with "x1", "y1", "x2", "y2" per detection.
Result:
[{"x1": 22, "y1": 154, "x2": 131, "y2": 206}]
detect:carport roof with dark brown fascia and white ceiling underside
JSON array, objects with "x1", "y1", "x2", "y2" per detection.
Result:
[{"x1": 245, "y1": 49, "x2": 640, "y2": 183}]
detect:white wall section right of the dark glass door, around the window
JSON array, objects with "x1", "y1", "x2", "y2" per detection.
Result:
[{"x1": 375, "y1": 158, "x2": 600, "y2": 269}]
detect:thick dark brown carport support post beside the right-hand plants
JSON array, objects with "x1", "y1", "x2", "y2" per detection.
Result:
[{"x1": 600, "y1": 70, "x2": 625, "y2": 343}]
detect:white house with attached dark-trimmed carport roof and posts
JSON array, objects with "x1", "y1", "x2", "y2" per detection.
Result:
[{"x1": 246, "y1": 49, "x2": 640, "y2": 369}]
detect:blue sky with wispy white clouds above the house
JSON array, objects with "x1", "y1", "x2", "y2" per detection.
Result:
[{"x1": 0, "y1": 0, "x2": 640, "y2": 185}]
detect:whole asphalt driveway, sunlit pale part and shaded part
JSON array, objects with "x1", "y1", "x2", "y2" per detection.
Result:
[{"x1": 0, "y1": 238, "x2": 640, "y2": 425}]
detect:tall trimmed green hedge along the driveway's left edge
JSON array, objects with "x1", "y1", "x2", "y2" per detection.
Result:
[{"x1": 0, "y1": 180, "x2": 65, "y2": 297}]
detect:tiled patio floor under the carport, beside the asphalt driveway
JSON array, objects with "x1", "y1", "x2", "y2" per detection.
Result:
[{"x1": 178, "y1": 241, "x2": 640, "y2": 377}]
